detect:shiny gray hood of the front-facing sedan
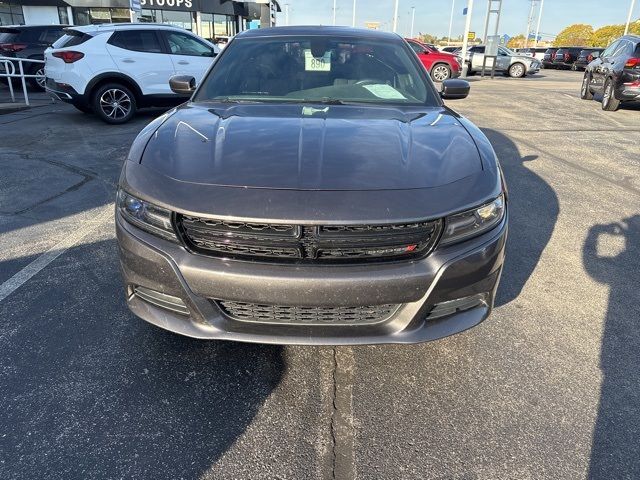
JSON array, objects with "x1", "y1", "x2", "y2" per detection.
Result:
[{"x1": 141, "y1": 103, "x2": 482, "y2": 190}]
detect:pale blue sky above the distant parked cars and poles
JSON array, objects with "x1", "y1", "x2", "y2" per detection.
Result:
[{"x1": 278, "y1": 0, "x2": 640, "y2": 39}]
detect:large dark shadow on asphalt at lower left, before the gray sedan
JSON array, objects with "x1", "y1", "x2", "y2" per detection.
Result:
[{"x1": 0, "y1": 239, "x2": 285, "y2": 479}]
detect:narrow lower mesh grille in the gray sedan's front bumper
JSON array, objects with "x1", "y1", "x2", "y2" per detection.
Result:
[{"x1": 216, "y1": 300, "x2": 399, "y2": 325}]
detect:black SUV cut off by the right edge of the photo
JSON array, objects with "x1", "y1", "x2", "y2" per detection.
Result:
[{"x1": 580, "y1": 35, "x2": 640, "y2": 111}]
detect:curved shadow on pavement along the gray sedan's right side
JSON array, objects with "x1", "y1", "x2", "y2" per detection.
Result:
[{"x1": 483, "y1": 129, "x2": 560, "y2": 306}]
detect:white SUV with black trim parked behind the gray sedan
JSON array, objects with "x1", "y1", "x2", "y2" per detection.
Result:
[{"x1": 45, "y1": 23, "x2": 220, "y2": 123}]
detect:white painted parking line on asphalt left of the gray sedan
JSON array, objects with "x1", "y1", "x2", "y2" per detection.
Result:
[{"x1": 0, "y1": 206, "x2": 113, "y2": 302}]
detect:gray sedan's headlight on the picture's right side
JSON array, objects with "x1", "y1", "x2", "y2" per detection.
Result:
[{"x1": 440, "y1": 194, "x2": 505, "y2": 245}]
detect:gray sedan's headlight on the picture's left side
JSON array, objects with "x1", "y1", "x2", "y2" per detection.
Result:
[{"x1": 117, "y1": 189, "x2": 178, "y2": 242}]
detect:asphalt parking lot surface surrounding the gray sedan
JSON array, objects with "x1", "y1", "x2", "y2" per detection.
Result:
[{"x1": 0, "y1": 71, "x2": 640, "y2": 479}]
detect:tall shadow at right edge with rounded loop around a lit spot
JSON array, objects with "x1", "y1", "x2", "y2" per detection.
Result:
[{"x1": 582, "y1": 215, "x2": 640, "y2": 479}]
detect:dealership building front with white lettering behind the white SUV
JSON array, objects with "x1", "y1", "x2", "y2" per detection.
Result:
[{"x1": 0, "y1": 0, "x2": 274, "y2": 41}]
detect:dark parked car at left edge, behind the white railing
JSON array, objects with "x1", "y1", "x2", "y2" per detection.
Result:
[{"x1": 0, "y1": 25, "x2": 66, "y2": 90}]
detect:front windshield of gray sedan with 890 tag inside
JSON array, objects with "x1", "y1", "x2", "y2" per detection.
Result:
[{"x1": 194, "y1": 36, "x2": 437, "y2": 105}]
